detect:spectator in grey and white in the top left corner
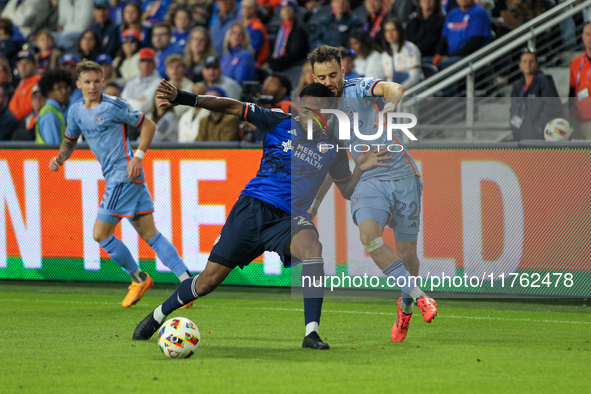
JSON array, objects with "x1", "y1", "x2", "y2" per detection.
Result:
[{"x1": 2, "y1": 0, "x2": 50, "y2": 37}]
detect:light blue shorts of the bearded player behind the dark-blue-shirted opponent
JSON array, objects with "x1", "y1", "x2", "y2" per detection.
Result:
[{"x1": 351, "y1": 176, "x2": 423, "y2": 241}]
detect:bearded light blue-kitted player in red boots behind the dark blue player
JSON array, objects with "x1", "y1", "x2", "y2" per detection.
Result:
[{"x1": 308, "y1": 45, "x2": 437, "y2": 342}]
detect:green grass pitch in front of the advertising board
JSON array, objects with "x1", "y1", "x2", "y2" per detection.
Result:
[{"x1": 0, "y1": 281, "x2": 591, "y2": 394}]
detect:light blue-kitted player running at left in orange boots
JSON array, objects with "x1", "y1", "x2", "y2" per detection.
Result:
[{"x1": 49, "y1": 60, "x2": 191, "y2": 307}]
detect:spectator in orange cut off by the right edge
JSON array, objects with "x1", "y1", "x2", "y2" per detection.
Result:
[{"x1": 568, "y1": 23, "x2": 591, "y2": 140}]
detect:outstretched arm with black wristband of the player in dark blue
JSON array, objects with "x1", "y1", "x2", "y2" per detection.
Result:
[{"x1": 156, "y1": 79, "x2": 242, "y2": 116}]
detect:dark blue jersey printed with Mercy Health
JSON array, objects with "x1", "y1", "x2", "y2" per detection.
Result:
[{"x1": 242, "y1": 103, "x2": 351, "y2": 215}]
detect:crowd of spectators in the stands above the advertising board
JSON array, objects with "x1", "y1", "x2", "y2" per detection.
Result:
[{"x1": 0, "y1": 0, "x2": 591, "y2": 144}]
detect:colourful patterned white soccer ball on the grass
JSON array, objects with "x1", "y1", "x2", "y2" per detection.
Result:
[{"x1": 158, "y1": 317, "x2": 201, "y2": 358}]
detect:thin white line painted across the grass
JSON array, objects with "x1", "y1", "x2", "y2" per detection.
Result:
[{"x1": 0, "y1": 298, "x2": 591, "y2": 325}]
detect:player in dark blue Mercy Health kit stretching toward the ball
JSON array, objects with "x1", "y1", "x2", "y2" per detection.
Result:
[{"x1": 133, "y1": 80, "x2": 388, "y2": 349}]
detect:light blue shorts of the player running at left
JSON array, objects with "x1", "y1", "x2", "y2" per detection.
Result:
[{"x1": 96, "y1": 182, "x2": 154, "y2": 224}]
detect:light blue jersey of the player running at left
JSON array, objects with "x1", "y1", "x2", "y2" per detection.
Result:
[{"x1": 66, "y1": 94, "x2": 145, "y2": 183}]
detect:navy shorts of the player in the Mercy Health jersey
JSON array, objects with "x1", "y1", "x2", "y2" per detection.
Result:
[{"x1": 208, "y1": 194, "x2": 316, "y2": 269}]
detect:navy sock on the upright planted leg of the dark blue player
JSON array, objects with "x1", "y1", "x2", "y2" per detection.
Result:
[{"x1": 302, "y1": 257, "x2": 324, "y2": 335}]
